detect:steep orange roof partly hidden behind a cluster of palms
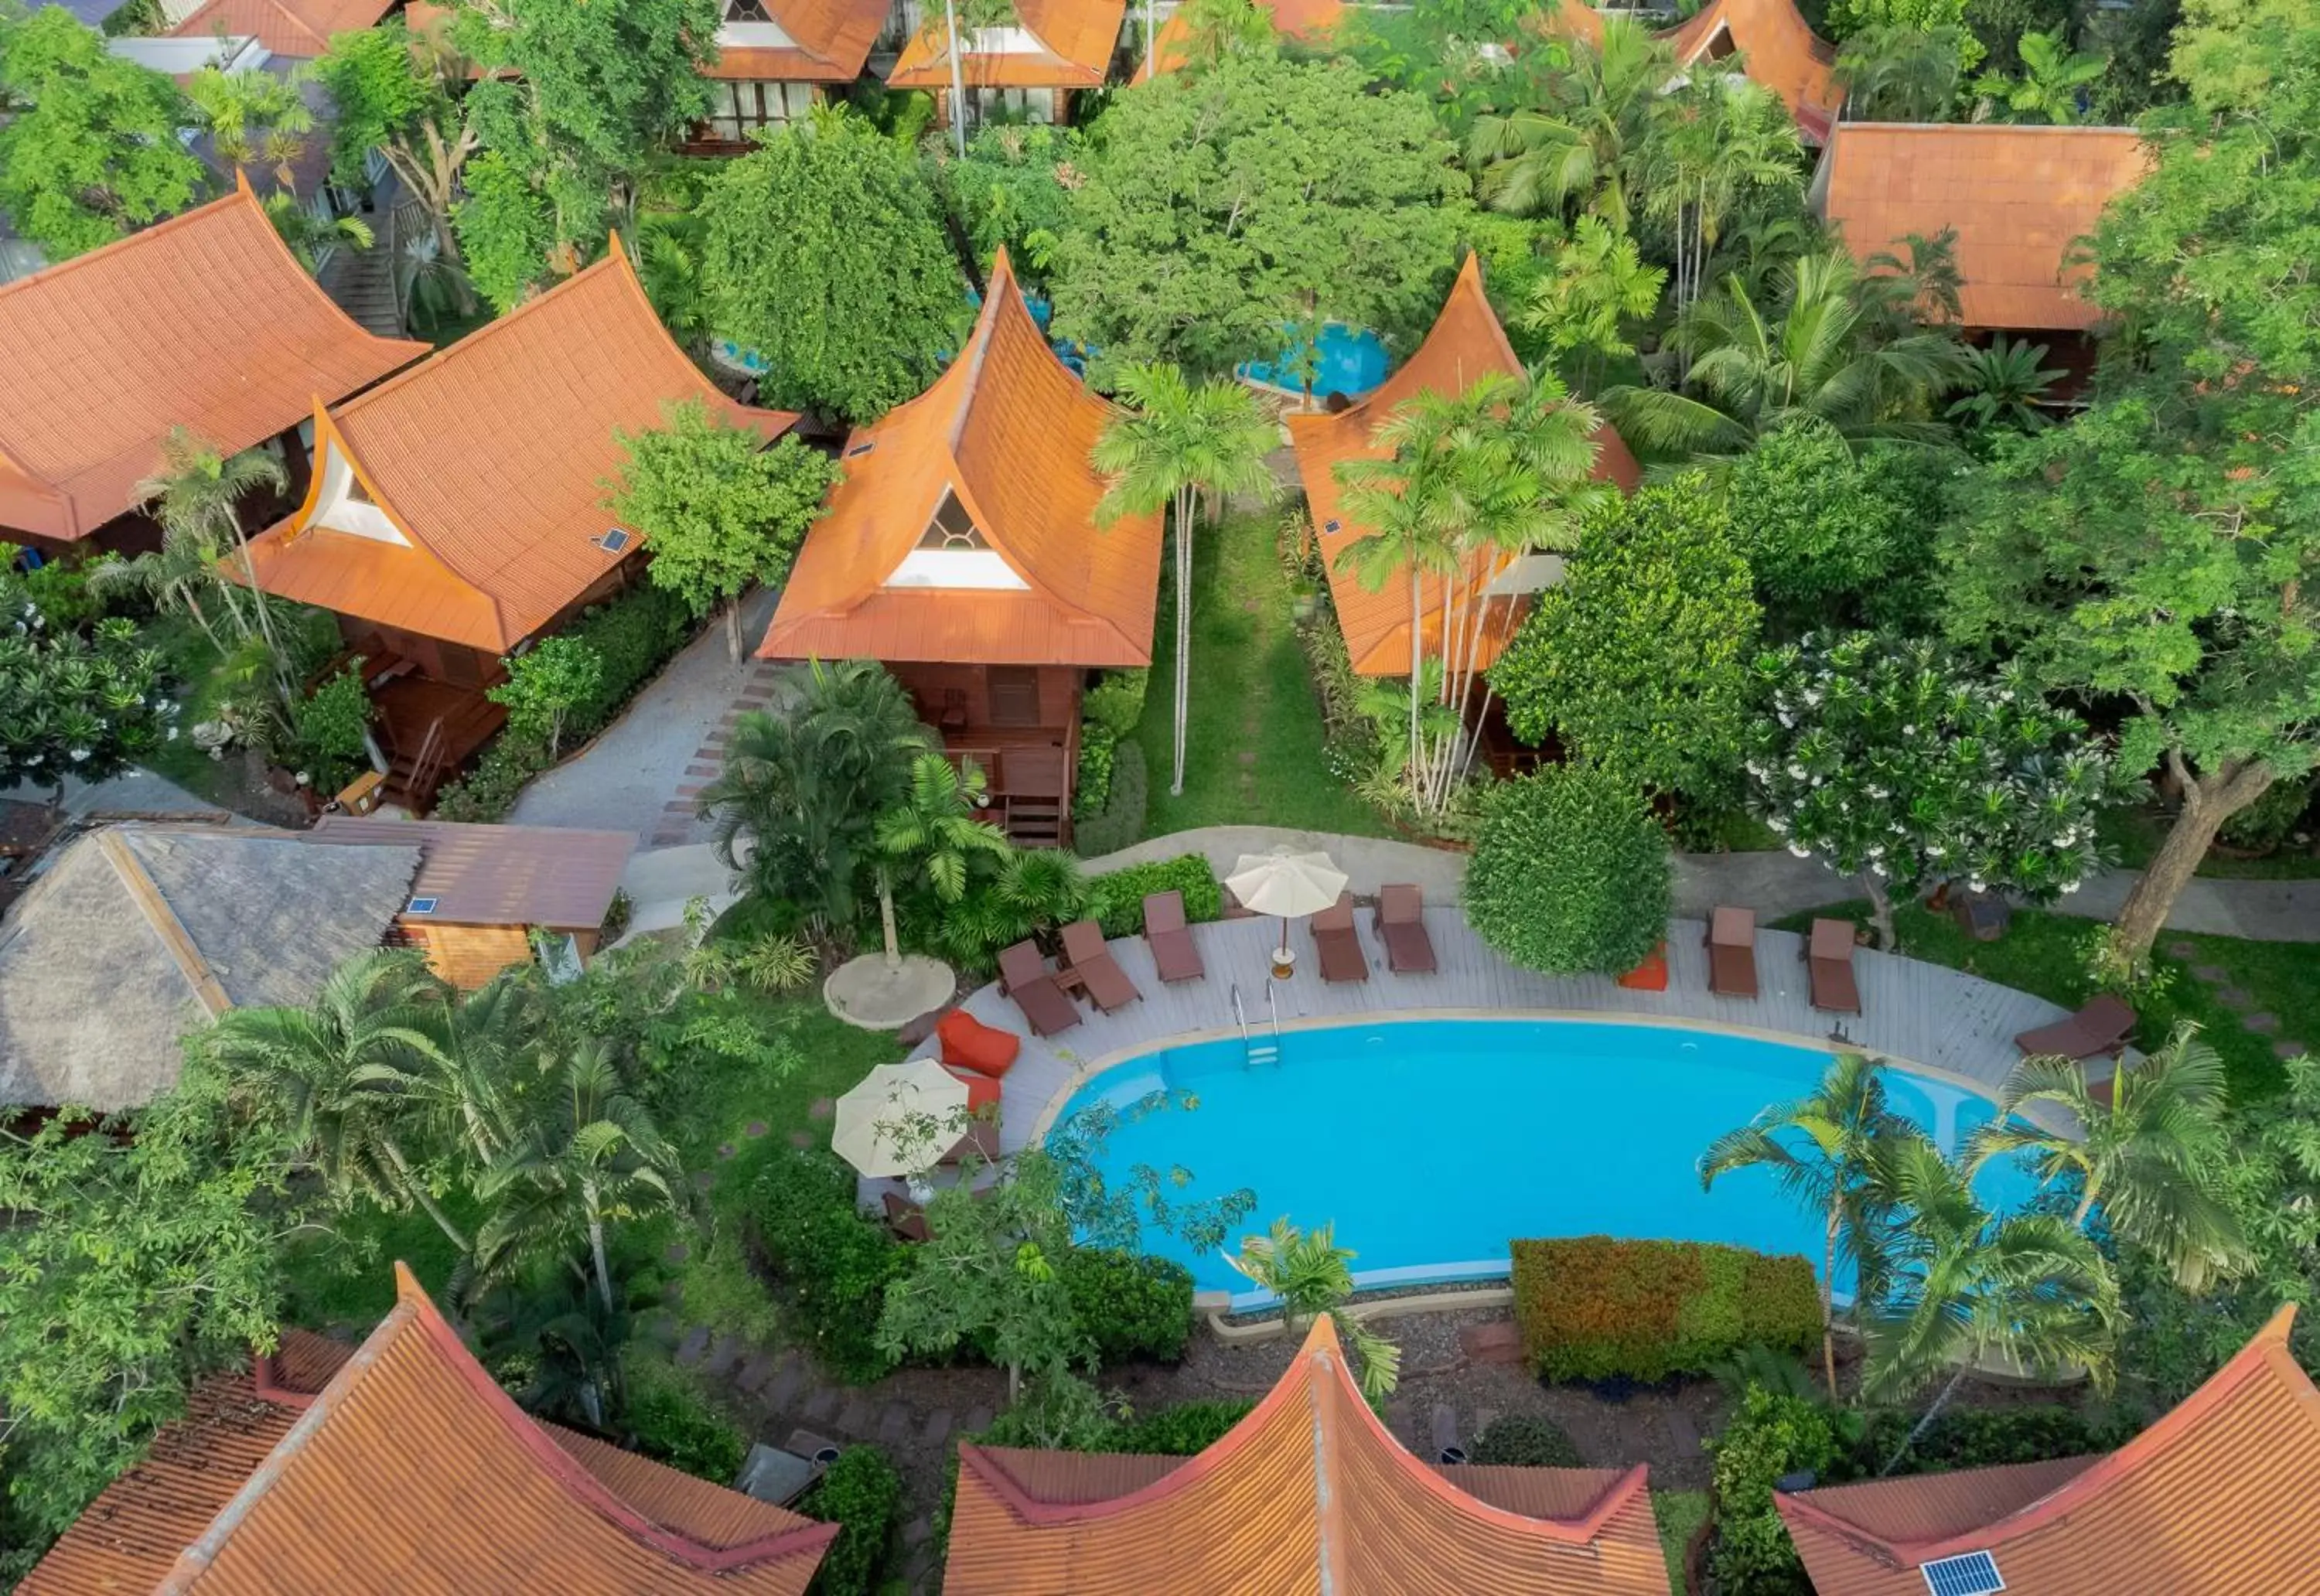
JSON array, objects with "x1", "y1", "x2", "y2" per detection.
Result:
[{"x1": 1288, "y1": 253, "x2": 1643, "y2": 675}]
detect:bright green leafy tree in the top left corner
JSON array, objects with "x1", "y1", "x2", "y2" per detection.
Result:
[{"x1": 0, "y1": 5, "x2": 204, "y2": 260}]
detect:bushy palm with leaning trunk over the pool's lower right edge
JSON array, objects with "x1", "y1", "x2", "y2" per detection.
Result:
[{"x1": 1861, "y1": 1134, "x2": 2120, "y2": 1473}]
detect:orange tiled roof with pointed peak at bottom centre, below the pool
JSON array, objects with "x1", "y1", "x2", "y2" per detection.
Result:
[{"x1": 942, "y1": 1318, "x2": 1668, "y2": 1596}]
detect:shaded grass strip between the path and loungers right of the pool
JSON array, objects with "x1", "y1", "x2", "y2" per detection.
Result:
[{"x1": 1775, "y1": 900, "x2": 2320, "y2": 1100}]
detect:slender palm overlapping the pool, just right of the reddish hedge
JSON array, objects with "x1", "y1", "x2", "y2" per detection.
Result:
[{"x1": 1701, "y1": 1053, "x2": 1905, "y2": 1401}]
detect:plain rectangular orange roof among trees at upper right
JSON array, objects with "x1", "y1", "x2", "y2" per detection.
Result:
[{"x1": 1821, "y1": 123, "x2": 2148, "y2": 332}]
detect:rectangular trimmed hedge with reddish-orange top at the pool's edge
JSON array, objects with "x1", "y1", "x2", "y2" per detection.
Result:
[{"x1": 1513, "y1": 1236, "x2": 1821, "y2": 1380}]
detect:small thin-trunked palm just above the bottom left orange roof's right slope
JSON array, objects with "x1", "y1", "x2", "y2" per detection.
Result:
[{"x1": 476, "y1": 1037, "x2": 684, "y2": 1313}]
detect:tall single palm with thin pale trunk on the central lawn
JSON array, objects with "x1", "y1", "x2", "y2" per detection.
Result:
[{"x1": 1090, "y1": 367, "x2": 1281, "y2": 793}]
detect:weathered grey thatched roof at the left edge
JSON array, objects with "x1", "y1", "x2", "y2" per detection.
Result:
[{"x1": 0, "y1": 824, "x2": 420, "y2": 1111}]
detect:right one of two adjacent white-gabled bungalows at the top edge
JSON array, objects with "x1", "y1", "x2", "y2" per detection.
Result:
[{"x1": 886, "y1": 0, "x2": 1128, "y2": 132}]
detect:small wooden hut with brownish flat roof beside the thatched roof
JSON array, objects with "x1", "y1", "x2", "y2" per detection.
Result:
[{"x1": 306, "y1": 814, "x2": 636, "y2": 991}]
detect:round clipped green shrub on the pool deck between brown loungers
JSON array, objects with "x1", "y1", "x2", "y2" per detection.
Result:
[{"x1": 1464, "y1": 766, "x2": 1673, "y2": 974}]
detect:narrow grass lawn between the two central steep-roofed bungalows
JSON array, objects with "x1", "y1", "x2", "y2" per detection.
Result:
[{"x1": 1134, "y1": 515, "x2": 1390, "y2": 837}]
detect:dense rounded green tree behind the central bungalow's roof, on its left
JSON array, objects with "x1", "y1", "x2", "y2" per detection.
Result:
[{"x1": 701, "y1": 109, "x2": 967, "y2": 422}]
